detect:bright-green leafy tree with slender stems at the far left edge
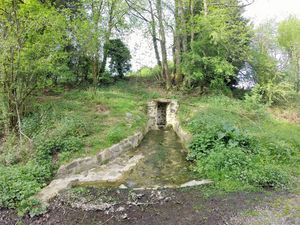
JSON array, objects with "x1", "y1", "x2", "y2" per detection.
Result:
[{"x1": 0, "y1": 0, "x2": 68, "y2": 137}]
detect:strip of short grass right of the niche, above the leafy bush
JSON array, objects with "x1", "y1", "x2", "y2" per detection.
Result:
[{"x1": 179, "y1": 96, "x2": 300, "y2": 148}]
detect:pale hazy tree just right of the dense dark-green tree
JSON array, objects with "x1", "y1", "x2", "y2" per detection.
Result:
[{"x1": 249, "y1": 21, "x2": 291, "y2": 105}]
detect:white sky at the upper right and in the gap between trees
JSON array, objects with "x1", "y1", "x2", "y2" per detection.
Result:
[{"x1": 126, "y1": 0, "x2": 300, "y2": 70}]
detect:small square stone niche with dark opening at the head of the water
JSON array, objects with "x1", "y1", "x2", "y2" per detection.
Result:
[{"x1": 148, "y1": 99, "x2": 178, "y2": 130}]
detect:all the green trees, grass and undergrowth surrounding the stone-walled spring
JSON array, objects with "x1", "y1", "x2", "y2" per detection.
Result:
[{"x1": 0, "y1": 0, "x2": 300, "y2": 220}]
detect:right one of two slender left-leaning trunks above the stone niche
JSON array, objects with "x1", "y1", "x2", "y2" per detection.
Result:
[{"x1": 156, "y1": 0, "x2": 171, "y2": 90}]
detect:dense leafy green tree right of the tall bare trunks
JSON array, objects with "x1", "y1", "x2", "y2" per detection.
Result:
[{"x1": 183, "y1": 1, "x2": 251, "y2": 88}]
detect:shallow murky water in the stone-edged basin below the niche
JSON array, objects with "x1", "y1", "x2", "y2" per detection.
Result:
[{"x1": 81, "y1": 129, "x2": 193, "y2": 188}]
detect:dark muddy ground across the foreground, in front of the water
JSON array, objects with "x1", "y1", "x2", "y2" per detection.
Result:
[{"x1": 0, "y1": 188, "x2": 300, "y2": 225}]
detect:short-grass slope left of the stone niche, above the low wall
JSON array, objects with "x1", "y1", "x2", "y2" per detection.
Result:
[{"x1": 33, "y1": 83, "x2": 147, "y2": 162}]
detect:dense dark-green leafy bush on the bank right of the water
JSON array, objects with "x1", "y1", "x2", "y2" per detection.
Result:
[{"x1": 187, "y1": 121, "x2": 294, "y2": 188}]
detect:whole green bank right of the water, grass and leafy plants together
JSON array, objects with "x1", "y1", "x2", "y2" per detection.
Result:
[{"x1": 180, "y1": 96, "x2": 300, "y2": 191}]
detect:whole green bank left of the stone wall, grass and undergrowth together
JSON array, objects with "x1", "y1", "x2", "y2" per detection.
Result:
[{"x1": 0, "y1": 79, "x2": 164, "y2": 215}]
